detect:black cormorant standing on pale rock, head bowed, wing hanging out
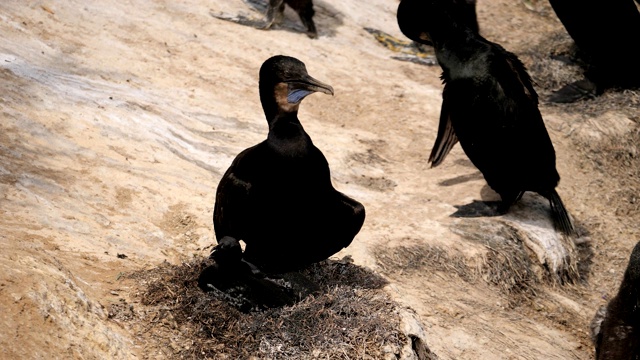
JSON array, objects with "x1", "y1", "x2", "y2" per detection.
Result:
[{"x1": 397, "y1": 0, "x2": 575, "y2": 235}]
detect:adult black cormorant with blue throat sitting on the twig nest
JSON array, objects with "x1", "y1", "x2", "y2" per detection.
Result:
[{"x1": 212, "y1": 55, "x2": 365, "y2": 273}]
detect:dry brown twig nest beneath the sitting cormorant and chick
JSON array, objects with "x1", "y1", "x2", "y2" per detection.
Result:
[{"x1": 115, "y1": 259, "x2": 410, "y2": 359}]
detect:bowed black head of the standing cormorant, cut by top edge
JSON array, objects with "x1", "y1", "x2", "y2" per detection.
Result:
[{"x1": 396, "y1": 0, "x2": 478, "y2": 45}]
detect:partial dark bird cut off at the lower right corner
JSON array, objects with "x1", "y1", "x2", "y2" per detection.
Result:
[{"x1": 593, "y1": 242, "x2": 640, "y2": 360}]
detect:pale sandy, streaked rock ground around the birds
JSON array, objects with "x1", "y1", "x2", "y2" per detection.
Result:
[{"x1": 0, "y1": 0, "x2": 640, "y2": 359}]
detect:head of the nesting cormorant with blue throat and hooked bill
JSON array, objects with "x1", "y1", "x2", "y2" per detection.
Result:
[{"x1": 260, "y1": 55, "x2": 333, "y2": 120}]
